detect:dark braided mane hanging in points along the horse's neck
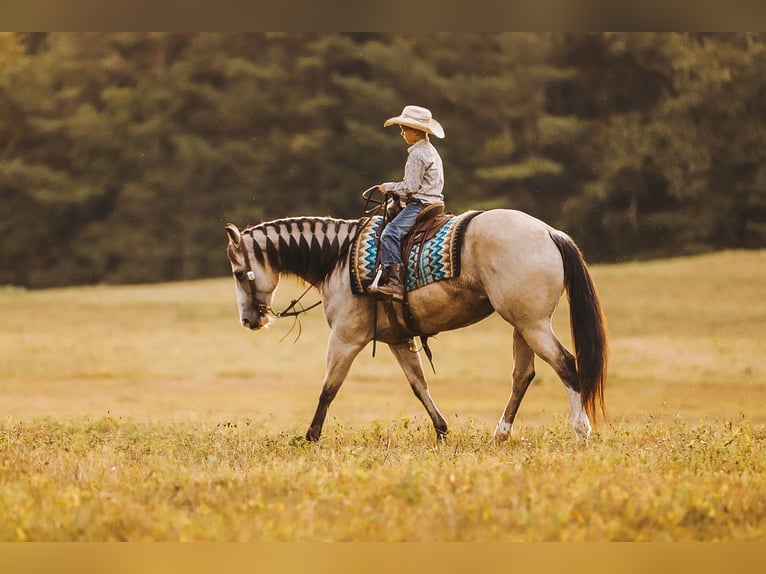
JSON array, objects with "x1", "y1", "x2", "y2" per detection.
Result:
[{"x1": 243, "y1": 217, "x2": 359, "y2": 285}]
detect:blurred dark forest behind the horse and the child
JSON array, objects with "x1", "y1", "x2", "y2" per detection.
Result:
[{"x1": 0, "y1": 33, "x2": 766, "y2": 288}]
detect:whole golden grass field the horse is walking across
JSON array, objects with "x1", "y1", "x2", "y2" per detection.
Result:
[{"x1": 0, "y1": 251, "x2": 766, "y2": 541}]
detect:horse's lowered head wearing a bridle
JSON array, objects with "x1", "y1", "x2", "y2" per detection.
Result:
[{"x1": 226, "y1": 223, "x2": 279, "y2": 330}]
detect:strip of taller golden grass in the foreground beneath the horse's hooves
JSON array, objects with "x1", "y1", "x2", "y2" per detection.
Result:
[{"x1": 0, "y1": 417, "x2": 766, "y2": 541}]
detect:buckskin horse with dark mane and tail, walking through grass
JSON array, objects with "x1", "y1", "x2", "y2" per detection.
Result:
[{"x1": 225, "y1": 209, "x2": 608, "y2": 442}]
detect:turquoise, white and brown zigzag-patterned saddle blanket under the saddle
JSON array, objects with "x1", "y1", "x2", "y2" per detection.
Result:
[{"x1": 349, "y1": 211, "x2": 481, "y2": 295}]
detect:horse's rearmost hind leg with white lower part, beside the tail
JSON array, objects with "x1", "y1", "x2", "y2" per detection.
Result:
[{"x1": 523, "y1": 322, "x2": 591, "y2": 441}]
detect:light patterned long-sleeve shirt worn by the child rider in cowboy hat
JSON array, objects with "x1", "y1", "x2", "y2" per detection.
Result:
[{"x1": 383, "y1": 139, "x2": 444, "y2": 203}]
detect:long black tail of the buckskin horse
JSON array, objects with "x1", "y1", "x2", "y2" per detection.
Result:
[{"x1": 550, "y1": 230, "x2": 609, "y2": 422}]
